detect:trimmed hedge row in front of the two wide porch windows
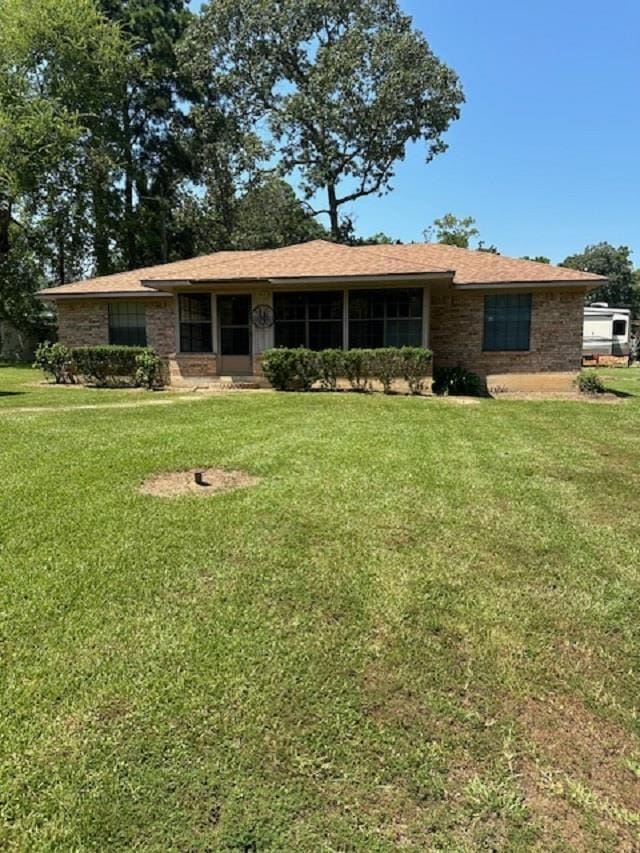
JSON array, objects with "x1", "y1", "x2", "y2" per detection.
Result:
[{"x1": 262, "y1": 347, "x2": 432, "y2": 394}]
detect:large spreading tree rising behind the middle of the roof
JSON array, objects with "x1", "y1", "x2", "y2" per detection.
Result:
[{"x1": 182, "y1": 0, "x2": 464, "y2": 239}]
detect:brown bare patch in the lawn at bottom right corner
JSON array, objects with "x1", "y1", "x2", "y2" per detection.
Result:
[{"x1": 519, "y1": 697, "x2": 640, "y2": 851}]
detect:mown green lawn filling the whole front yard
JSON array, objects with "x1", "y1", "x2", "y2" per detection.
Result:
[{"x1": 0, "y1": 368, "x2": 640, "y2": 853}]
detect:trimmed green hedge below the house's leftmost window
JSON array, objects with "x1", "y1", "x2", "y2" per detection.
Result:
[{"x1": 33, "y1": 343, "x2": 164, "y2": 389}]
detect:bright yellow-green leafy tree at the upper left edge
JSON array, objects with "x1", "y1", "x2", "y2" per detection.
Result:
[{"x1": 0, "y1": 0, "x2": 121, "y2": 256}]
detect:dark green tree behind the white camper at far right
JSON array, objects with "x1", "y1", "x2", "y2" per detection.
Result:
[{"x1": 561, "y1": 243, "x2": 640, "y2": 312}]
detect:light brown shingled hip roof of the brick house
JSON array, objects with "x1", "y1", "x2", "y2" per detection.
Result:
[{"x1": 38, "y1": 240, "x2": 603, "y2": 299}]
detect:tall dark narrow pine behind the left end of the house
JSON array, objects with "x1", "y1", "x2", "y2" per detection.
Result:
[{"x1": 95, "y1": 0, "x2": 195, "y2": 272}]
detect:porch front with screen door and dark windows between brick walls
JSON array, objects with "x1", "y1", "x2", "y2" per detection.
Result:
[{"x1": 169, "y1": 281, "x2": 432, "y2": 384}]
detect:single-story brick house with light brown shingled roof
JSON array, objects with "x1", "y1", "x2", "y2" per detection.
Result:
[{"x1": 39, "y1": 240, "x2": 604, "y2": 390}]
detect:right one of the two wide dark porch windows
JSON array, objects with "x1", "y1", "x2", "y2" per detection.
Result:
[{"x1": 349, "y1": 288, "x2": 423, "y2": 349}]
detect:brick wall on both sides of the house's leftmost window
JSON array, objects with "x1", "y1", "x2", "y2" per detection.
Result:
[{"x1": 57, "y1": 298, "x2": 176, "y2": 356}]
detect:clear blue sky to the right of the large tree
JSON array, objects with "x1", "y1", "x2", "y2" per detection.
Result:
[{"x1": 188, "y1": 0, "x2": 640, "y2": 266}]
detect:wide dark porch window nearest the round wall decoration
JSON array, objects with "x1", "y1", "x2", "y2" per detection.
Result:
[{"x1": 273, "y1": 290, "x2": 342, "y2": 350}]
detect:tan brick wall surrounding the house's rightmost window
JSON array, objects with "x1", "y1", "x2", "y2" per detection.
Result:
[{"x1": 431, "y1": 290, "x2": 584, "y2": 376}]
